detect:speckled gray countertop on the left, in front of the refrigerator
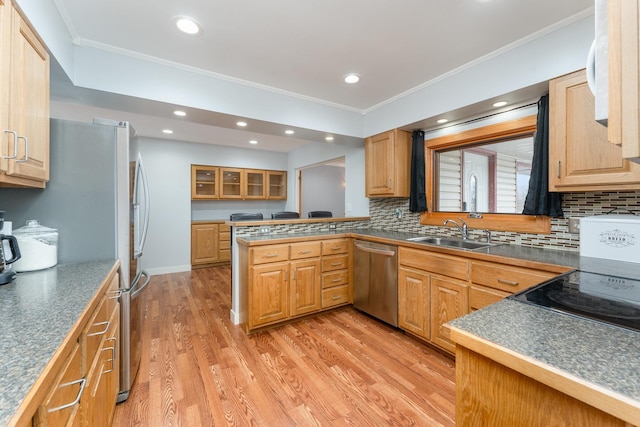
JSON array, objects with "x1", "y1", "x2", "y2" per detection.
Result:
[{"x1": 0, "y1": 260, "x2": 116, "y2": 425}]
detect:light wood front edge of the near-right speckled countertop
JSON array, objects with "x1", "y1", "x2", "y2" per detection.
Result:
[{"x1": 448, "y1": 325, "x2": 640, "y2": 425}]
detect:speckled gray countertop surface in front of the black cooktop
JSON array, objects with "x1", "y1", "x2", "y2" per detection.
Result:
[{"x1": 448, "y1": 299, "x2": 640, "y2": 421}]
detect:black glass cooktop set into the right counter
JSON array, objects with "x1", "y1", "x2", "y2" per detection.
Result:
[{"x1": 510, "y1": 271, "x2": 640, "y2": 331}]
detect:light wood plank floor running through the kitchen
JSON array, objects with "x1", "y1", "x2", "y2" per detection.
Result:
[{"x1": 113, "y1": 267, "x2": 455, "y2": 427}]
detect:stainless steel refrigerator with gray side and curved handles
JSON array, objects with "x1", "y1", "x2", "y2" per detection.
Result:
[{"x1": 0, "y1": 119, "x2": 149, "y2": 402}]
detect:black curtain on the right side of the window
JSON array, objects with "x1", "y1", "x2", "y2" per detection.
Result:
[{"x1": 522, "y1": 95, "x2": 563, "y2": 217}]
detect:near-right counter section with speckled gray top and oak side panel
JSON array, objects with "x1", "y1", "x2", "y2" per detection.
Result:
[{"x1": 448, "y1": 257, "x2": 640, "y2": 426}]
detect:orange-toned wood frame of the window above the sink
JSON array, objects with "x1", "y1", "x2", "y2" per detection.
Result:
[{"x1": 420, "y1": 115, "x2": 551, "y2": 234}]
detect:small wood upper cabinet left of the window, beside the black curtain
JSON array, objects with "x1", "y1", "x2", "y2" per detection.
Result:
[{"x1": 364, "y1": 129, "x2": 411, "y2": 197}]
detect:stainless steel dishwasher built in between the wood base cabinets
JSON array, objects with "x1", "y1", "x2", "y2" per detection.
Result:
[{"x1": 353, "y1": 240, "x2": 398, "y2": 326}]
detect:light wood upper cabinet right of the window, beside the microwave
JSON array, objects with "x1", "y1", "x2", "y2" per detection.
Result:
[{"x1": 549, "y1": 70, "x2": 640, "y2": 191}]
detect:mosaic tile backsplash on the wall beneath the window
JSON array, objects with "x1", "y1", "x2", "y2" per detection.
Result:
[{"x1": 369, "y1": 191, "x2": 640, "y2": 251}]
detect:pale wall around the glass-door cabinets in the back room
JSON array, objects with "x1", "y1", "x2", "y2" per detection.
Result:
[{"x1": 140, "y1": 138, "x2": 287, "y2": 275}]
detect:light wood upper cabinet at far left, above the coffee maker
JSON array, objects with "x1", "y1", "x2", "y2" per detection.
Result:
[{"x1": 0, "y1": 0, "x2": 49, "y2": 188}]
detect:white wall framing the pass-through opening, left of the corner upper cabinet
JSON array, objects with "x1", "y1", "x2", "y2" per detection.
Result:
[{"x1": 287, "y1": 142, "x2": 369, "y2": 217}]
